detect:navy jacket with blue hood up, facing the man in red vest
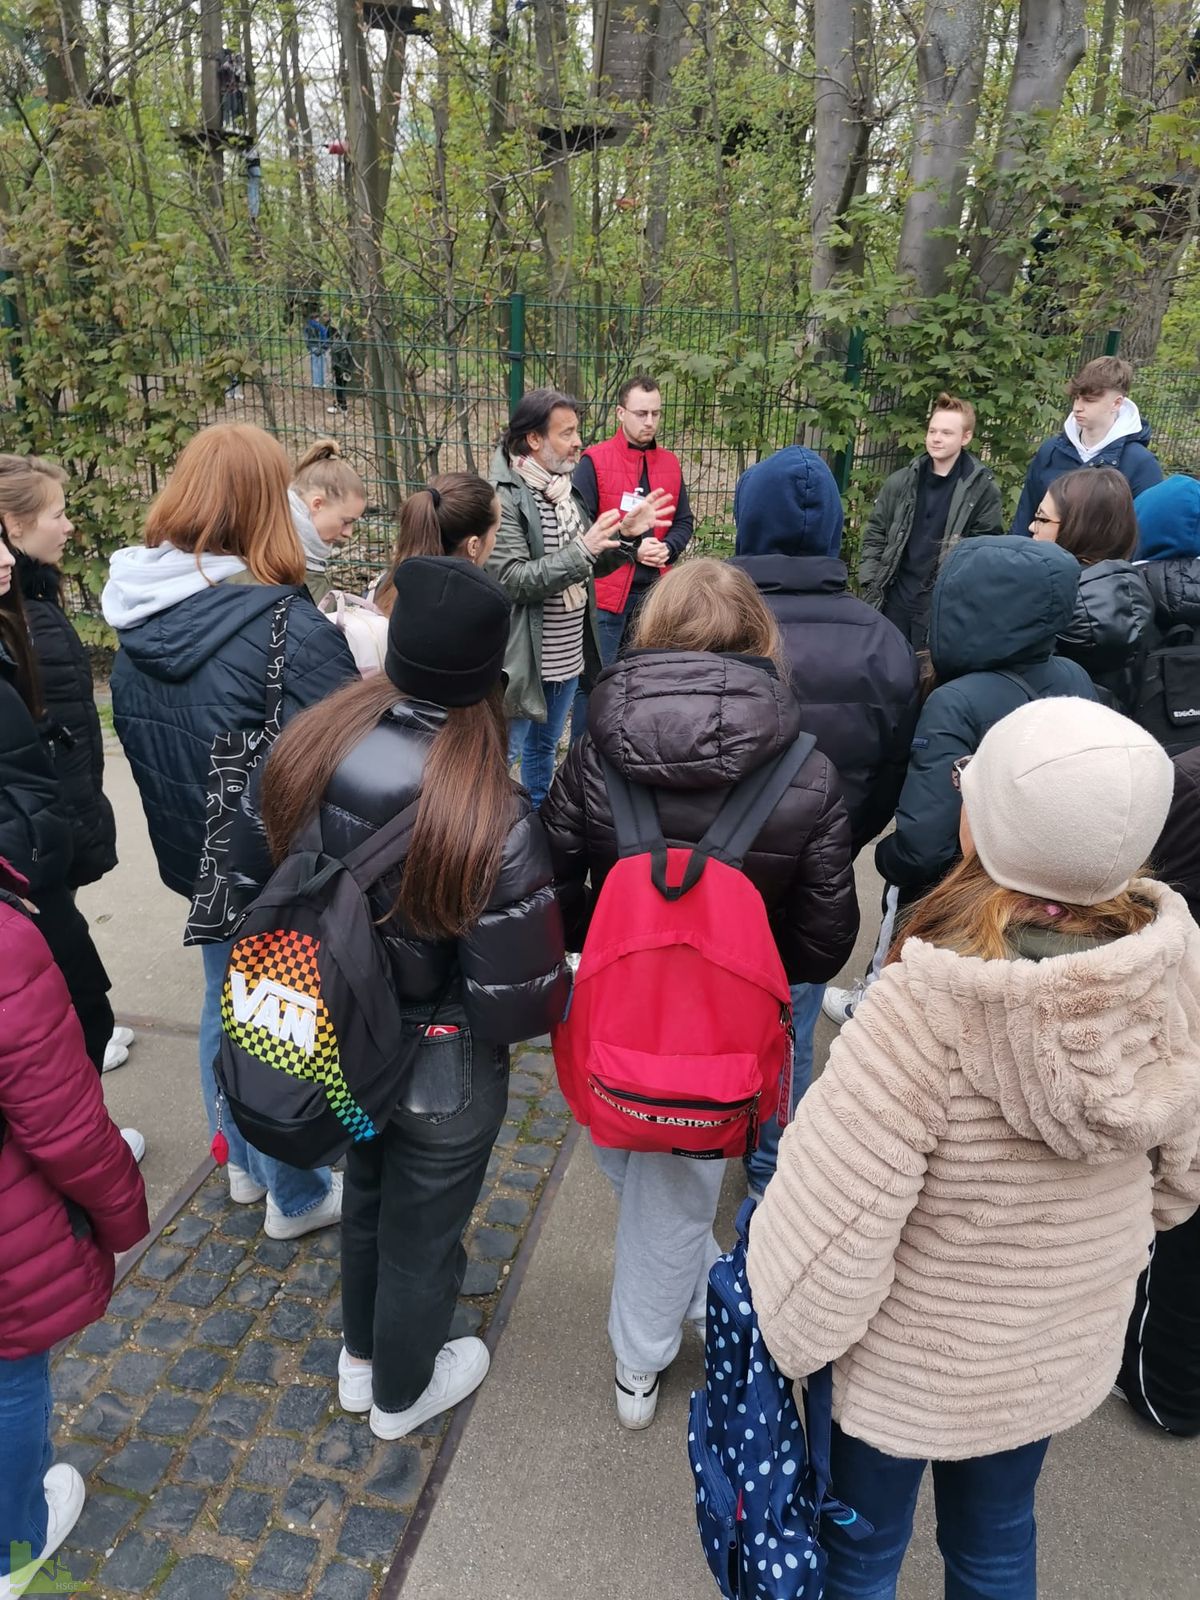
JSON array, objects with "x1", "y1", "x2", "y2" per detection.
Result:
[{"x1": 733, "y1": 445, "x2": 917, "y2": 851}]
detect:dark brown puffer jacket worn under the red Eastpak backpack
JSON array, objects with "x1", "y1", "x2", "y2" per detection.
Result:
[{"x1": 541, "y1": 650, "x2": 858, "y2": 984}]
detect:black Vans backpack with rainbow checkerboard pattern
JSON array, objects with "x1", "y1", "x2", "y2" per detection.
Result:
[{"x1": 214, "y1": 802, "x2": 426, "y2": 1166}]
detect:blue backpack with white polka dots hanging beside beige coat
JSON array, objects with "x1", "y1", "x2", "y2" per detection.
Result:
[{"x1": 688, "y1": 1200, "x2": 874, "y2": 1600}]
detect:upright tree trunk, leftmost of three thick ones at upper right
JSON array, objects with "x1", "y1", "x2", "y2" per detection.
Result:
[{"x1": 808, "y1": 0, "x2": 872, "y2": 294}]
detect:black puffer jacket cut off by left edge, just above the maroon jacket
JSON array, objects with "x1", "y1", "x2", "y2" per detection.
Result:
[{"x1": 0, "y1": 645, "x2": 74, "y2": 899}]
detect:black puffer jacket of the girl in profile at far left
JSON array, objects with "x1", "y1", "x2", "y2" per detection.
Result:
[{"x1": 16, "y1": 552, "x2": 117, "y2": 890}]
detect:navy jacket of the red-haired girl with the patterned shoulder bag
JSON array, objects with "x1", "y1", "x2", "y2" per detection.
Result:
[{"x1": 106, "y1": 582, "x2": 358, "y2": 896}]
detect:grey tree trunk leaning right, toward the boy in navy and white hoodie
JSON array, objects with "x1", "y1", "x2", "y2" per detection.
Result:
[{"x1": 974, "y1": 0, "x2": 1088, "y2": 294}]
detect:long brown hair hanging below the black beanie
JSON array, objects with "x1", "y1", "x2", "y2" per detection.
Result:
[{"x1": 262, "y1": 677, "x2": 515, "y2": 939}]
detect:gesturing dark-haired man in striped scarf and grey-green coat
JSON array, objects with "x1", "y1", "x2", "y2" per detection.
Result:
[{"x1": 488, "y1": 389, "x2": 672, "y2": 806}]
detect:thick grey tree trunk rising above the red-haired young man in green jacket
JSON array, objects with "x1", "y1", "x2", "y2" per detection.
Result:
[{"x1": 896, "y1": 0, "x2": 987, "y2": 302}]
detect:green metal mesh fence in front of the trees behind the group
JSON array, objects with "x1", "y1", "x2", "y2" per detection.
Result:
[{"x1": 0, "y1": 285, "x2": 1200, "y2": 598}]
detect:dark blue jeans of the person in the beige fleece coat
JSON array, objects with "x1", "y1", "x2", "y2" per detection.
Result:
[{"x1": 821, "y1": 1422, "x2": 1050, "y2": 1600}]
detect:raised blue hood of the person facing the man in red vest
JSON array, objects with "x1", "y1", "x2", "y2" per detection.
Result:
[{"x1": 733, "y1": 445, "x2": 843, "y2": 555}]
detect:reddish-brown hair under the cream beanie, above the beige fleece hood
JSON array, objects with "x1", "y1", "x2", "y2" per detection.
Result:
[{"x1": 886, "y1": 853, "x2": 1157, "y2": 966}]
